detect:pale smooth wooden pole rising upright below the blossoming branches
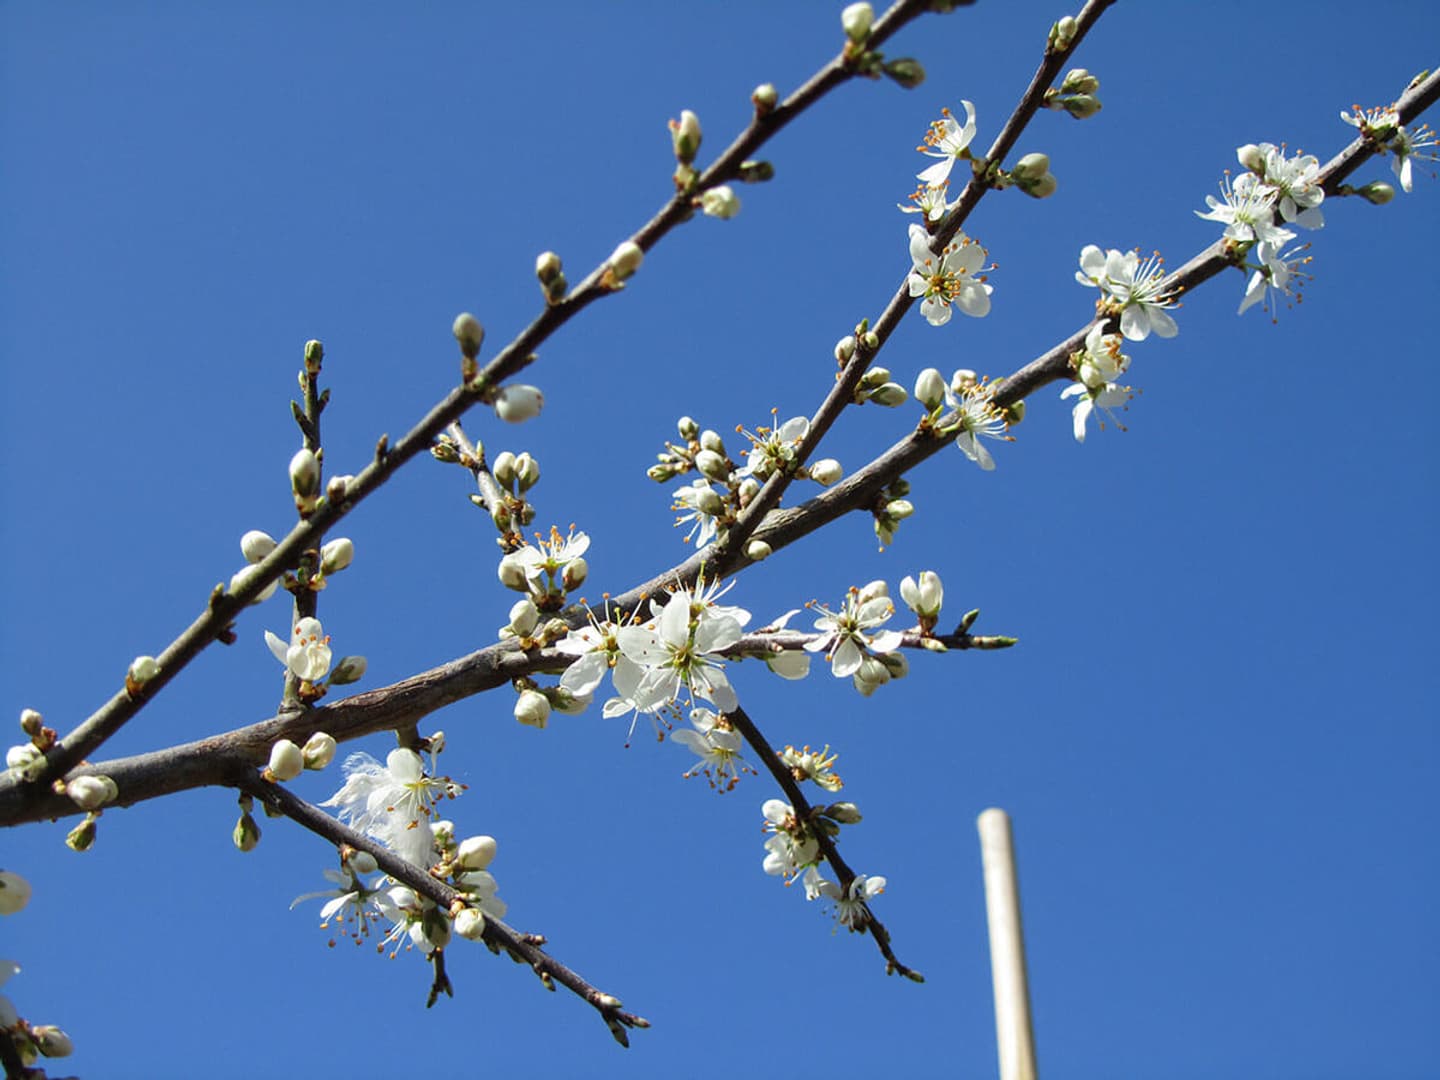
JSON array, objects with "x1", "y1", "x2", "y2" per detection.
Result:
[{"x1": 975, "y1": 806, "x2": 1038, "y2": 1080}]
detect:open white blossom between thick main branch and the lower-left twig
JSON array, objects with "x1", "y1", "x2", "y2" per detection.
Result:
[{"x1": 320, "y1": 747, "x2": 462, "y2": 867}]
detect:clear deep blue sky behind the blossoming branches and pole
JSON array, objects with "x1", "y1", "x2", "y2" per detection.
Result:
[{"x1": 0, "y1": 1, "x2": 1440, "y2": 1080}]
